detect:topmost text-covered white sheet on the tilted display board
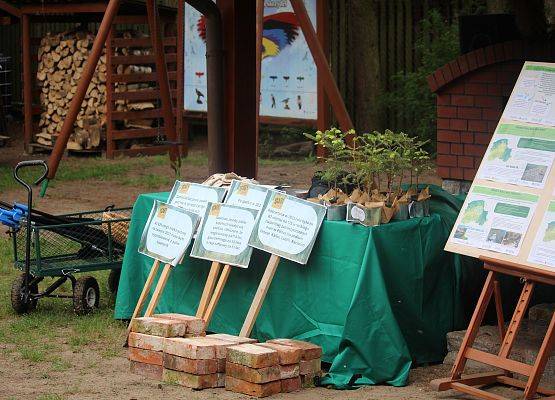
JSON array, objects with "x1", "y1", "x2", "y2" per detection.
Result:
[{"x1": 503, "y1": 63, "x2": 555, "y2": 126}]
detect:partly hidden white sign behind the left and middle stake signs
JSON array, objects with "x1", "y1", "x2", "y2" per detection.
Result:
[{"x1": 168, "y1": 181, "x2": 226, "y2": 217}]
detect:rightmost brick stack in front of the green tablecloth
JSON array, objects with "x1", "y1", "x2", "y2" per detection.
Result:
[{"x1": 225, "y1": 339, "x2": 322, "y2": 397}]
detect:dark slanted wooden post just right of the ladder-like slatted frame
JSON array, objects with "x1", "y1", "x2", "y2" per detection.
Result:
[{"x1": 146, "y1": 0, "x2": 180, "y2": 167}]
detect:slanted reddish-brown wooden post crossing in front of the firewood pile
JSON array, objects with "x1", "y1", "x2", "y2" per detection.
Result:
[{"x1": 45, "y1": 0, "x2": 120, "y2": 182}]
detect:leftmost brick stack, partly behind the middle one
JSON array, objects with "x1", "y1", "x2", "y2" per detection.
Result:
[{"x1": 127, "y1": 314, "x2": 205, "y2": 380}]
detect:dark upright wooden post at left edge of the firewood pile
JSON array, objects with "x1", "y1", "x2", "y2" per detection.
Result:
[{"x1": 21, "y1": 14, "x2": 34, "y2": 152}]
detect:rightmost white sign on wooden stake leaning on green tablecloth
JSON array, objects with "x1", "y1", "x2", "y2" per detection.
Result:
[{"x1": 239, "y1": 190, "x2": 326, "y2": 337}]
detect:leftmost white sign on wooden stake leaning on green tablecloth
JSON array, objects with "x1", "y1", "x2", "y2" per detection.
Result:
[{"x1": 127, "y1": 200, "x2": 199, "y2": 342}]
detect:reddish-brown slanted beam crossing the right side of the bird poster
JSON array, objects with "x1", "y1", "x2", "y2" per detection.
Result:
[{"x1": 291, "y1": 0, "x2": 353, "y2": 130}]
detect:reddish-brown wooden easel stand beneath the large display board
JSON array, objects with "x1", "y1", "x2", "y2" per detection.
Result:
[{"x1": 432, "y1": 257, "x2": 555, "y2": 400}]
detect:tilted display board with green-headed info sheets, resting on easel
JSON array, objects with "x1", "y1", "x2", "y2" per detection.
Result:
[{"x1": 445, "y1": 62, "x2": 555, "y2": 275}]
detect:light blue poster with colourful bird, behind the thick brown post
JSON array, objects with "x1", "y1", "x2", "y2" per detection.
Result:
[{"x1": 184, "y1": 0, "x2": 318, "y2": 119}]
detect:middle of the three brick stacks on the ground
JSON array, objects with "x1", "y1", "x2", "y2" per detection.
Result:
[{"x1": 162, "y1": 334, "x2": 256, "y2": 389}]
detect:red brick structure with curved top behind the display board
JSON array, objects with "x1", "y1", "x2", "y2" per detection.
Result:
[{"x1": 428, "y1": 40, "x2": 555, "y2": 186}]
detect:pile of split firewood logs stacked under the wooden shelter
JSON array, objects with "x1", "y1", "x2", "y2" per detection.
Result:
[{"x1": 36, "y1": 31, "x2": 107, "y2": 150}]
